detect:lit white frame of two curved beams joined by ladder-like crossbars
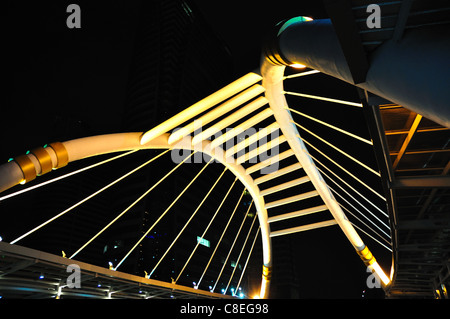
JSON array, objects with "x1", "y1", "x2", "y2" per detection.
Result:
[{"x1": 0, "y1": 68, "x2": 389, "y2": 298}]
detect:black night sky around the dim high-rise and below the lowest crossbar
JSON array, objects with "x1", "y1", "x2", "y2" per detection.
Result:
[{"x1": 0, "y1": 0, "x2": 388, "y2": 298}]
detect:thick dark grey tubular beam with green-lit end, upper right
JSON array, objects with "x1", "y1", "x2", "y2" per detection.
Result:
[{"x1": 270, "y1": 2, "x2": 450, "y2": 127}]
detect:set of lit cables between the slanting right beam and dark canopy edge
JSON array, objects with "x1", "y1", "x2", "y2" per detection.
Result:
[{"x1": 284, "y1": 71, "x2": 392, "y2": 251}]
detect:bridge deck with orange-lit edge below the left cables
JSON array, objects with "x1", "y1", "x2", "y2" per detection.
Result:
[{"x1": 0, "y1": 242, "x2": 234, "y2": 299}]
